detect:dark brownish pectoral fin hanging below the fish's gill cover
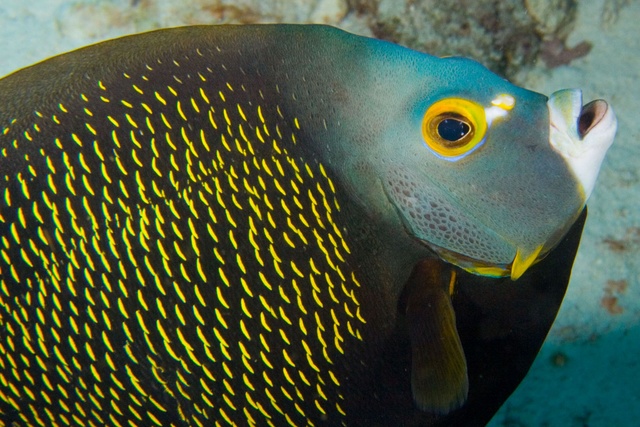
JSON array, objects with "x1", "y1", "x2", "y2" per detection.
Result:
[{"x1": 403, "y1": 259, "x2": 469, "y2": 414}]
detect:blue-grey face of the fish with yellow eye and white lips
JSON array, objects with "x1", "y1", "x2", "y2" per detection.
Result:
[{"x1": 383, "y1": 54, "x2": 616, "y2": 280}]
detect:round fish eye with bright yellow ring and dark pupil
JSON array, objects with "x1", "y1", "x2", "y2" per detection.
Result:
[{"x1": 422, "y1": 98, "x2": 487, "y2": 160}]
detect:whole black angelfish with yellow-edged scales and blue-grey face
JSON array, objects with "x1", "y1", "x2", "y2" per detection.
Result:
[{"x1": 0, "y1": 25, "x2": 615, "y2": 426}]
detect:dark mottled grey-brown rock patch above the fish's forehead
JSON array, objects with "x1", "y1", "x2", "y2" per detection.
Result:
[{"x1": 349, "y1": 0, "x2": 585, "y2": 77}]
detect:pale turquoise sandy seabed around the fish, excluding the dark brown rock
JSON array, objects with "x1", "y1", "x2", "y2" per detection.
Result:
[{"x1": 0, "y1": 0, "x2": 640, "y2": 427}]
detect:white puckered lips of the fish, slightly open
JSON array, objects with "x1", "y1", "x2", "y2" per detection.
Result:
[{"x1": 547, "y1": 89, "x2": 617, "y2": 203}]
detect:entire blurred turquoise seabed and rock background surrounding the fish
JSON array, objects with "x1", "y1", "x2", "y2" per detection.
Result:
[{"x1": 0, "y1": 0, "x2": 640, "y2": 427}]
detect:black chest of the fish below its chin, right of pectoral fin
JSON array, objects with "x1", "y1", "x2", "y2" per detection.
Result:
[{"x1": 430, "y1": 208, "x2": 586, "y2": 427}]
